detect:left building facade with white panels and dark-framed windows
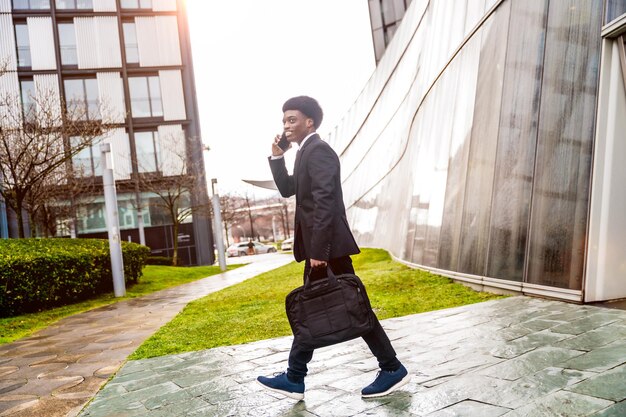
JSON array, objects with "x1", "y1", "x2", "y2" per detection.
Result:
[{"x1": 0, "y1": 0, "x2": 214, "y2": 264}]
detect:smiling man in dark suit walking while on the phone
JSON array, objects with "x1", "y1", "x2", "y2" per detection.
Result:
[{"x1": 257, "y1": 96, "x2": 409, "y2": 400}]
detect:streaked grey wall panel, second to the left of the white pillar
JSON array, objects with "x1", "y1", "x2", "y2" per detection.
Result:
[{"x1": 487, "y1": 0, "x2": 548, "y2": 281}]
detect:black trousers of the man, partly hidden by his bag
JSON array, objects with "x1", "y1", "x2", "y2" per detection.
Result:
[{"x1": 287, "y1": 256, "x2": 400, "y2": 382}]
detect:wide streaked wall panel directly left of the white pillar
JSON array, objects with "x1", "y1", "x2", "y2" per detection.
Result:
[{"x1": 526, "y1": 0, "x2": 602, "y2": 290}]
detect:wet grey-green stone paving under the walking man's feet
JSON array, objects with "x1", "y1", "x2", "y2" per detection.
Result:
[{"x1": 81, "y1": 297, "x2": 626, "y2": 417}]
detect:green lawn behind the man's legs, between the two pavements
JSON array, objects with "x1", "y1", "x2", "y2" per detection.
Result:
[{"x1": 130, "y1": 249, "x2": 502, "y2": 359}]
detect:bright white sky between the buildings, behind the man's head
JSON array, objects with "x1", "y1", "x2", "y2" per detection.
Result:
[{"x1": 187, "y1": 0, "x2": 375, "y2": 198}]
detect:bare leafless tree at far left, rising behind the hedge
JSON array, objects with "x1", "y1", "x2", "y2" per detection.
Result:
[{"x1": 0, "y1": 86, "x2": 112, "y2": 237}]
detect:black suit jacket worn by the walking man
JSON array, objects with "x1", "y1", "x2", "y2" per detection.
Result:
[{"x1": 269, "y1": 134, "x2": 359, "y2": 262}]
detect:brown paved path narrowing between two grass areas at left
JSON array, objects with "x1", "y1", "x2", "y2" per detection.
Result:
[{"x1": 0, "y1": 254, "x2": 293, "y2": 417}]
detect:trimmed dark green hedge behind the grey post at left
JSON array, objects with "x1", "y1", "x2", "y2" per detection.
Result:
[{"x1": 0, "y1": 239, "x2": 150, "y2": 317}]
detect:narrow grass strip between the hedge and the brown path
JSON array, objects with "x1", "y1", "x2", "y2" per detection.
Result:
[{"x1": 0, "y1": 265, "x2": 241, "y2": 344}]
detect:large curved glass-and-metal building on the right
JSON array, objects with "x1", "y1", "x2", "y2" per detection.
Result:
[{"x1": 329, "y1": 0, "x2": 626, "y2": 302}]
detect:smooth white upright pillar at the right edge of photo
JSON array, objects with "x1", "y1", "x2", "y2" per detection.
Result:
[{"x1": 585, "y1": 38, "x2": 626, "y2": 302}]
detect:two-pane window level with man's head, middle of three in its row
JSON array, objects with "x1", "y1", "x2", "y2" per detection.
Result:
[{"x1": 63, "y1": 78, "x2": 101, "y2": 120}]
